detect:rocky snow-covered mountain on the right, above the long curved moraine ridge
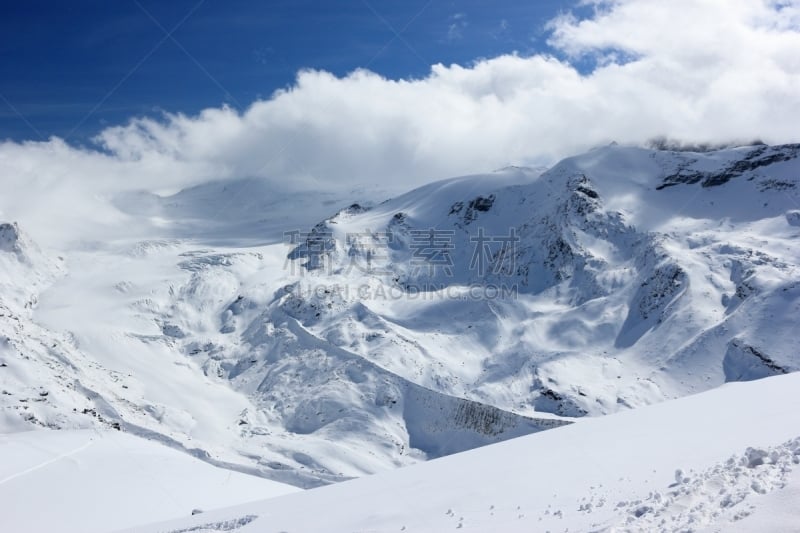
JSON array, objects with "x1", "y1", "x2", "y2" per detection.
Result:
[{"x1": 283, "y1": 145, "x2": 800, "y2": 416}]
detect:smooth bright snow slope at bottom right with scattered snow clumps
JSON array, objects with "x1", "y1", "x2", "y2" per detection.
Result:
[{"x1": 132, "y1": 374, "x2": 800, "y2": 533}]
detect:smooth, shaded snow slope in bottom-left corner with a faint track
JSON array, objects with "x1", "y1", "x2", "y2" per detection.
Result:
[{"x1": 0, "y1": 430, "x2": 298, "y2": 533}]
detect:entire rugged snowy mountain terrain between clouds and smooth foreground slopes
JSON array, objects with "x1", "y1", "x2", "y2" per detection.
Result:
[{"x1": 0, "y1": 145, "x2": 800, "y2": 528}]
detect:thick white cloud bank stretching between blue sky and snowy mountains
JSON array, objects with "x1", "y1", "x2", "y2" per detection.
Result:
[{"x1": 0, "y1": 0, "x2": 800, "y2": 242}]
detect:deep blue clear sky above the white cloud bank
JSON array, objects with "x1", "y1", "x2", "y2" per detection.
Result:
[{"x1": 0, "y1": 0, "x2": 574, "y2": 143}]
